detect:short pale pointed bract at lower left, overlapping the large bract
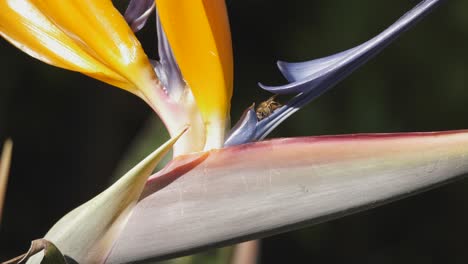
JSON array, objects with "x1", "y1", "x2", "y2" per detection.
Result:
[{"x1": 39, "y1": 129, "x2": 189, "y2": 263}]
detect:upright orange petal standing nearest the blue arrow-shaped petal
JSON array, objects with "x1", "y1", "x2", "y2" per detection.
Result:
[{"x1": 156, "y1": 0, "x2": 233, "y2": 148}]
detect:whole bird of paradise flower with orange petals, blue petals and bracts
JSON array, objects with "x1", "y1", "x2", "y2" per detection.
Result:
[{"x1": 0, "y1": 0, "x2": 468, "y2": 263}]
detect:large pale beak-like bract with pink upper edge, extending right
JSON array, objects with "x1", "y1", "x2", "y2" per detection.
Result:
[{"x1": 106, "y1": 130, "x2": 468, "y2": 263}]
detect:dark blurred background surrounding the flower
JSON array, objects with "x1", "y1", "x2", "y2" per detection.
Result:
[{"x1": 0, "y1": 0, "x2": 468, "y2": 263}]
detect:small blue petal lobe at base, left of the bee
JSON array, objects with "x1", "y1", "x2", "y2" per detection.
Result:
[{"x1": 224, "y1": 105, "x2": 257, "y2": 147}]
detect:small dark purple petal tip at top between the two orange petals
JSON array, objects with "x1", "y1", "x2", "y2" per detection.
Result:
[{"x1": 124, "y1": 0, "x2": 155, "y2": 32}]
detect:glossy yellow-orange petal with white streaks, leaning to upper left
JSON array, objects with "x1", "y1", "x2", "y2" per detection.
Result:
[{"x1": 0, "y1": 0, "x2": 156, "y2": 94}]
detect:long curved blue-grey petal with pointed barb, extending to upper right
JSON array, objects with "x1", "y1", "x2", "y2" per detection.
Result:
[{"x1": 255, "y1": 0, "x2": 442, "y2": 140}]
